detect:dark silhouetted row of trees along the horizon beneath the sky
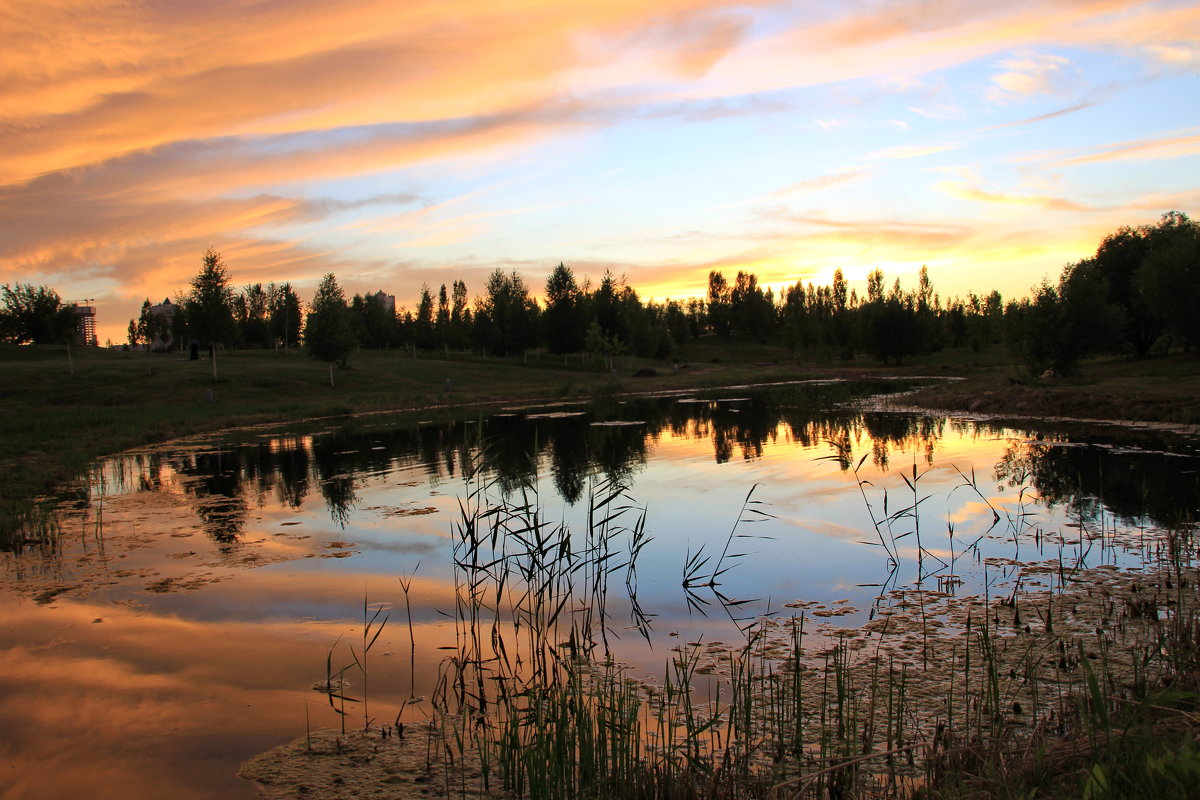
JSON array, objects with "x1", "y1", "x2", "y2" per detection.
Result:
[{"x1": 0, "y1": 211, "x2": 1200, "y2": 374}]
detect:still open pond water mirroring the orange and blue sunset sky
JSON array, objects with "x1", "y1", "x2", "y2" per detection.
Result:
[{"x1": 0, "y1": 383, "x2": 1200, "y2": 799}]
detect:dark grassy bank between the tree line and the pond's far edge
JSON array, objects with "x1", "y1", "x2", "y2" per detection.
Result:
[{"x1": 0, "y1": 343, "x2": 1200, "y2": 545}]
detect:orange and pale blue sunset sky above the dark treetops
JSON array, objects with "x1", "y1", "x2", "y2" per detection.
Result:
[{"x1": 0, "y1": 0, "x2": 1200, "y2": 342}]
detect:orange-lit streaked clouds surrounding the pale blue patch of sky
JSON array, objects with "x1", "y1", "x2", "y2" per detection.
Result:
[{"x1": 0, "y1": 0, "x2": 1200, "y2": 345}]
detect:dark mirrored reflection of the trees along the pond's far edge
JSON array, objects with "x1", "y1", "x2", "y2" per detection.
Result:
[{"x1": 63, "y1": 386, "x2": 1200, "y2": 551}]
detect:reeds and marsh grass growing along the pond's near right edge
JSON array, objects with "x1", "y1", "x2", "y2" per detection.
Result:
[{"x1": 369, "y1": 450, "x2": 1200, "y2": 800}]
